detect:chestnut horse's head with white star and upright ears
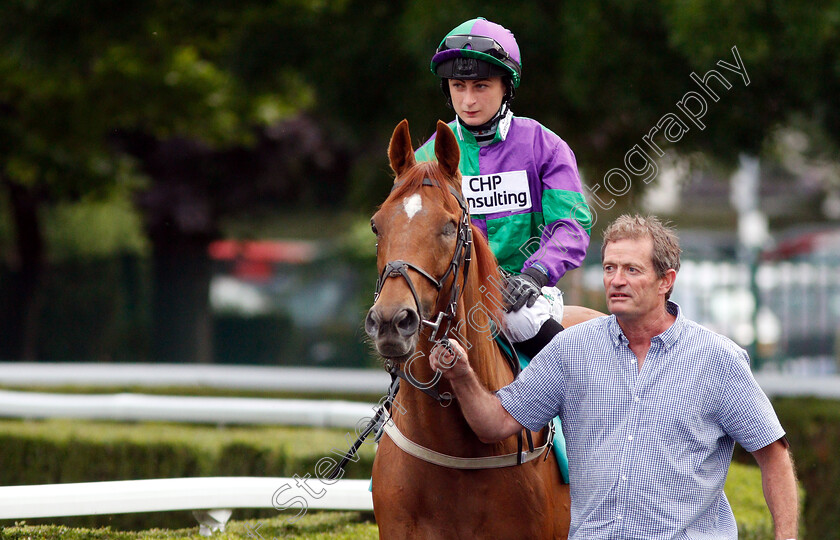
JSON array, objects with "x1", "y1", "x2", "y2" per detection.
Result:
[{"x1": 365, "y1": 120, "x2": 471, "y2": 362}]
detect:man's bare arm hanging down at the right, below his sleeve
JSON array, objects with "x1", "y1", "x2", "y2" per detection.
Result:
[{"x1": 752, "y1": 439, "x2": 799, "y2": 540}]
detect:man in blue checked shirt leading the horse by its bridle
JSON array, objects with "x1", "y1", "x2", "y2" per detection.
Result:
[{"x1": 429, "y1": 216, "x2": 798, "y2": 540}]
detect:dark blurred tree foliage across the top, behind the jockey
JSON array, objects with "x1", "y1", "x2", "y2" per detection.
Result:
[{"x1": 0, "y1": 0, "x2": 840, "y2": 360}]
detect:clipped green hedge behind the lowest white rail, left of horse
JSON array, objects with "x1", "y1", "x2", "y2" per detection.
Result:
[{"x1": 0, "y1": 420, "x2": 374, "y2": 529}]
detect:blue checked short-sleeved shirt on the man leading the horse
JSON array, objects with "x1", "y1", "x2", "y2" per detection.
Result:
[{"x1": 497, "y1": 302, "x2": 784, "y2": 540}]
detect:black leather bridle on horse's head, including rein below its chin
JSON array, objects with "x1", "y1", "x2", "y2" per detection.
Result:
[{"x1": 373, "y1": 178, "x2": 472, "y2": 405}]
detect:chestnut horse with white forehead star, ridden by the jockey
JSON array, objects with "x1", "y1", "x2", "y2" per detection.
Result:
[{"x1": 365, "y1": 120, "x2": 602, "y2": 540}]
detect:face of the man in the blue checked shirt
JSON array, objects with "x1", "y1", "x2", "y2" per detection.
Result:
[{"x1": 603, "y1": 238, "x2": 670, "y2": 321}]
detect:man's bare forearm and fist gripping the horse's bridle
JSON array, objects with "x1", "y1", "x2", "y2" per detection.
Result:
[{"x1": 429, "y1": 341, "x2": 524, "y2": 443}]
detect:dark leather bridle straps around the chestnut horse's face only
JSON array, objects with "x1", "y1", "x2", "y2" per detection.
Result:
[{"x1": 373, "y1": 178, "x2": 472, "y2": 342}]
